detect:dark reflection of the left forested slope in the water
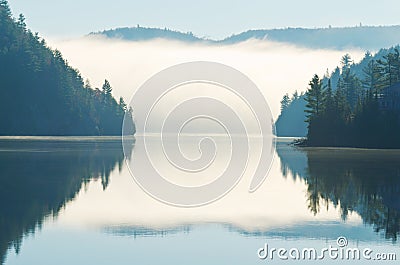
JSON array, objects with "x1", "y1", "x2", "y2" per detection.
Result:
[{"x1": 0, "y1": 138, "x2": 132, "y2": 264}]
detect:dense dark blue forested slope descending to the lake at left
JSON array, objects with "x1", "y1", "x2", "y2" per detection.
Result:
[{"x1": 0, "y1": 0, "x2": 133, "y2": 135}]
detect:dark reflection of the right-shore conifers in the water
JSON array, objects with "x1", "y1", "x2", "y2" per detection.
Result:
[{"x1": 277, "y1": 140, "x2": 400, "y2": 242}]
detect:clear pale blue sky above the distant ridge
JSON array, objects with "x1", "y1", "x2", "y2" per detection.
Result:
[{"x1": 9, "y1": 0, "x2": 400, "y2": 39}]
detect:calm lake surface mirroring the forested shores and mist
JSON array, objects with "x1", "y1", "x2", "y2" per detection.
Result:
[{"x1": 0, "y1": 137, "x2": 400, "y2": 265}]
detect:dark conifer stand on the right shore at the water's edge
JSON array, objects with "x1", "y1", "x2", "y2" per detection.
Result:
[{"x1": 303, "y1": 47, "x2": 400, "y2": 148}]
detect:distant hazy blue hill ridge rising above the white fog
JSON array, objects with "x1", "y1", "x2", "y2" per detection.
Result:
[{"x1": 89, "y1": 25, "x2": 400, "y2": 50}]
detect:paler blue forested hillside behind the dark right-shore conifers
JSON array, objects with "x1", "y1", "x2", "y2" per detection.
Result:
[{"x1": 276, "y1": 46, "x2": 400, "y2": 139}]
